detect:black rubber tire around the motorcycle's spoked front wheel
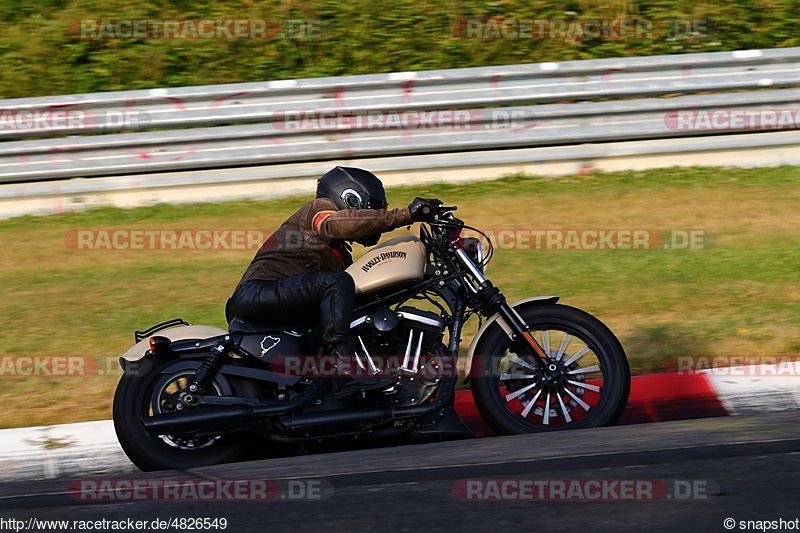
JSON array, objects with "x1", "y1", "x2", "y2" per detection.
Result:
[{"x1": 471, "y1": 302, "x2": 630, "y2": 435}]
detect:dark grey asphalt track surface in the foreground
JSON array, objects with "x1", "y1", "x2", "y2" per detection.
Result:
[{"x1": 0, "y1": 414, "x2": 800, "y2": 531}]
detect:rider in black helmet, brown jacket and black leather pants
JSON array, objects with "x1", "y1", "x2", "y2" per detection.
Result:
[{"x1": 226, "y1": 166, "x2": 441, "y2": 399}]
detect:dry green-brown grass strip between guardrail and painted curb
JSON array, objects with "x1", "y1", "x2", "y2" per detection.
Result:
[{"x1": 0, "y1": 167, "x2": 800, "y2": 427}]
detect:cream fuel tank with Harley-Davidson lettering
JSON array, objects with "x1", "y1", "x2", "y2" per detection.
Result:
[{"x1": 346, "y1": 235, "x2": 425, "y2": 295}]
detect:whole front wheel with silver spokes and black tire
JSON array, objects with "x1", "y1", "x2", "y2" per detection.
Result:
[{"x1": 471, "y1": 303, "x2": 630, "y2": 435}]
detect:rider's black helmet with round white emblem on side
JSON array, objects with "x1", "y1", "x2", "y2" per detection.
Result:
[{"x1": 317, "y1": 167, "x2": 386, "y2": 209}]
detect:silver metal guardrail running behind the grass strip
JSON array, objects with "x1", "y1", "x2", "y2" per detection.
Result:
[{"x1": 0, "y1": 48, "x2": 800, "y2": 183}]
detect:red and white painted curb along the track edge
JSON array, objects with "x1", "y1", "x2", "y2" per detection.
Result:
[{"x1": 0, "y1": 362, "x2": 800, "y2": 482}]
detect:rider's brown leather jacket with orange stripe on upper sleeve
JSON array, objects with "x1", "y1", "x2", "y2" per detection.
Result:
[{"x1": 239, "y1": 198, "x2": 411, "y2": 284}]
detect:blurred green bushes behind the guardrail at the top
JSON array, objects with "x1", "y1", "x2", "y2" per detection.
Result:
[{"x1": 0, "y1": 0, "x2": 800, "y2": 98}]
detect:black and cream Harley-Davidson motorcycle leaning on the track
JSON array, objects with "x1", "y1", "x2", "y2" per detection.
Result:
[{"x1": 114, "y1": 206, "x2": 630, "y2": 470}]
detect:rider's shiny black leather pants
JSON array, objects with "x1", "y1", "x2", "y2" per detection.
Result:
[{"x1": 226, "y1": 272, "x2": 356, "y2": 353}]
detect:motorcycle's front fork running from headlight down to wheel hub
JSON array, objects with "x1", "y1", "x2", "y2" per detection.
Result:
[{"x1": 456, "y1": 248, "x2": 549, "y2": 371}]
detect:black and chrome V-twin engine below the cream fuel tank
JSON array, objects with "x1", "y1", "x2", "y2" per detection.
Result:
[{"x1": 350, "y1": 307, "x2": 446, "y2": 405}]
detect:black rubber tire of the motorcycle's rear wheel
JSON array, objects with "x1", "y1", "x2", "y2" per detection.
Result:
[{"x1": 113, "y1": 360, "x2": 252, "y2": 471}]
